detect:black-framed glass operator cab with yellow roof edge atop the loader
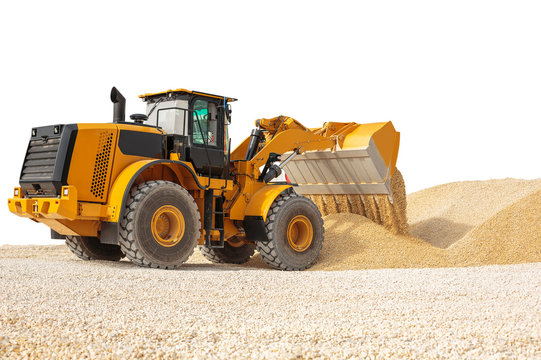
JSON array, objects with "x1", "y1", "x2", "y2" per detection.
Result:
[{"x1": 139, "y1": 89, "x2": 237, "y2": 178}]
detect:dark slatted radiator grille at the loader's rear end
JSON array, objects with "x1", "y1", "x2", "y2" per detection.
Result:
[{"x1": 21, "y1": 138, "x2": 60, "y2": 182}]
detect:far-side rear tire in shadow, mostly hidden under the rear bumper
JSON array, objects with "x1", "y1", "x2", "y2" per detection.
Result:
[{"x1": 66, "y1": 235, "x2": 124, "y2": 261}]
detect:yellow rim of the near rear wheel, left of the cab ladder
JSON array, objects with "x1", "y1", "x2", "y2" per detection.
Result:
[{"x1": 151, "y1": 205, "x2": 186, "y2": 247}]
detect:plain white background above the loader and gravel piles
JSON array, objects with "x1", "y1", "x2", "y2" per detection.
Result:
[{"x1": 0, "y1": 1, "x2": 541, "y2": 244}]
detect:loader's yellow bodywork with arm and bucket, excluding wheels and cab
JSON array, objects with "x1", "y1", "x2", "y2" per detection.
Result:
[{"x1": 8, "y1": 89, "x2": 400, "y2": 250}]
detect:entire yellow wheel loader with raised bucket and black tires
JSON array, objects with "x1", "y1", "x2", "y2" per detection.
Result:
[{"x1": 8, "y1": 88, "x2": 400, "y2": 270}]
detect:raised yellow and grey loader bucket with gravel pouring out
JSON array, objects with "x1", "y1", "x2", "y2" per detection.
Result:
[{"x1": 284, "y1": 122, "x2": 407, "y2": 233}]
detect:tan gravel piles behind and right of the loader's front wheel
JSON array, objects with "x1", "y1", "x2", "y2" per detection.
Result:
[{"x1": 220, "y1": 179, "x2": 541, "y2": 270}]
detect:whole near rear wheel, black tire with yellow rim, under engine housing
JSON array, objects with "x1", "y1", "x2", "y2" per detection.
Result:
[{"x1": 120, "y1": 181, "x2": 201, "y2": 269}]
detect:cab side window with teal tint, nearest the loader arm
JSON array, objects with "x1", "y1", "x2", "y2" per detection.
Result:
[{"x1": 193, "y1": 100, "x2": 218, "y2": 146}]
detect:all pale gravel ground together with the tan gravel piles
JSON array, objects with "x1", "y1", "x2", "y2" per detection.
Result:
[{"x1": 0, "y1": 179, "x2": 541, "y2": 359}]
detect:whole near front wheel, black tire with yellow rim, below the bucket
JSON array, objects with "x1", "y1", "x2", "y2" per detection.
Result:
[{"x1": 257, "y1": 192, "x2": 325, "y2": 270}]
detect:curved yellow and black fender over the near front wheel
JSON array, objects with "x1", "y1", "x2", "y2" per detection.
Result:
[{"x1": 242, "y1": 185, "x2": 293, "y2": 241}]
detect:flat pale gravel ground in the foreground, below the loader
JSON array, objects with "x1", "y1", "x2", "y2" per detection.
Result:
[{"x1": 0, "y1": 247, "x2": 541, "y2": 359}]
